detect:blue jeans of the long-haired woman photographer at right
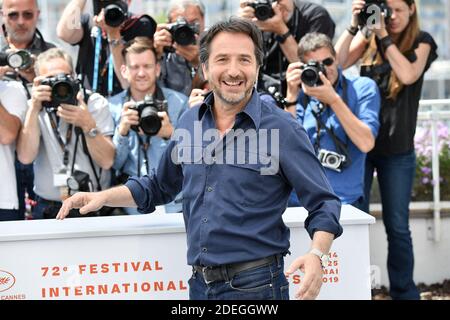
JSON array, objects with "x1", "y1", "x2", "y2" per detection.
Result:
[{"x1": 363, "y1": 152, "x2": 420, "y2": 299}]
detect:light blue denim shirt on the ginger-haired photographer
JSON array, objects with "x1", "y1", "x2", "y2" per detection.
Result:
[{"x1": 109, "y1": 88, "x2": 188, "y2": 214}]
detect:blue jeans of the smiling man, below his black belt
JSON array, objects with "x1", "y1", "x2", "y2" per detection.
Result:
[{"x1": 189, "y1": 258, "x2": 289, "y2": 300}]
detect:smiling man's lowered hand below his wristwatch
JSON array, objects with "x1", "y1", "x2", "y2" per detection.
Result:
[{"x1": 285, "y1": 253, "x2": 323, "y2": 300}]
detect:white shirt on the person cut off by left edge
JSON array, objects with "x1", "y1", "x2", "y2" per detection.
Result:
[{"x1": 0, "y1": 80, "x2": 27, "y2": 210}]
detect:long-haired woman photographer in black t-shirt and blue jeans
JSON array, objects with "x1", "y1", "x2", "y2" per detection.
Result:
[{"x1": 336, "y1": 0, "x2": 437, "y2": 299}]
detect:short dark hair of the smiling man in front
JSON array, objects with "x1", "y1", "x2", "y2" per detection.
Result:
[{"x1": 200, "y1": 17, "x2": 264, "y2": 66}]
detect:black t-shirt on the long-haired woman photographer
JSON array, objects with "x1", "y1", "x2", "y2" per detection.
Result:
[{"x1": 371, "y1": 31, "x2": 437, "y2": 155}]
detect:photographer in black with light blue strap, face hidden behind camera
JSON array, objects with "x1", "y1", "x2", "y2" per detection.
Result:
[{"x1": 56, "y1": 0, "x2": 156, "y2": 96}]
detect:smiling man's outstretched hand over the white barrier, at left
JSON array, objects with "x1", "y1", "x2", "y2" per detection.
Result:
[{"x1": 56, "y1": 192, "x2": 106, "y2": 220}]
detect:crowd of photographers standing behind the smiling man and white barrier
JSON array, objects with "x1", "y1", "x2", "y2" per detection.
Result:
[{"x1": 0, "y1": 0, "x2": 437, "y2": 298}]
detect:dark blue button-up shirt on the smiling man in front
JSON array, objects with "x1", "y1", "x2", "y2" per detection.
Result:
[{"x1": 126, "y1": 92, "x2": 342, "y2": 266}]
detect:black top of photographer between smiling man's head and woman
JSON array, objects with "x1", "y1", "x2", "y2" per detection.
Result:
[{"x1": 259, "y1": 0, "x2": 335, "y2": 93}]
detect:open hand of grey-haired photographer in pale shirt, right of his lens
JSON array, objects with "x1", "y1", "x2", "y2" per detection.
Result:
[{"x1": 57, "y1": 93, "x2": 96, "y2": 133}]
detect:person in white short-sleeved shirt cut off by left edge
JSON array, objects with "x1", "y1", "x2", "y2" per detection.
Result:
[{"x1": 0, "y1": 80, "x2": 27, "y2": 221}]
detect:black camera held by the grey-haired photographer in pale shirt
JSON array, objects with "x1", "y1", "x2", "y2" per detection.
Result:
[{"x1": 41, "y1": 73, "x2": 80, "y2": 111}]
